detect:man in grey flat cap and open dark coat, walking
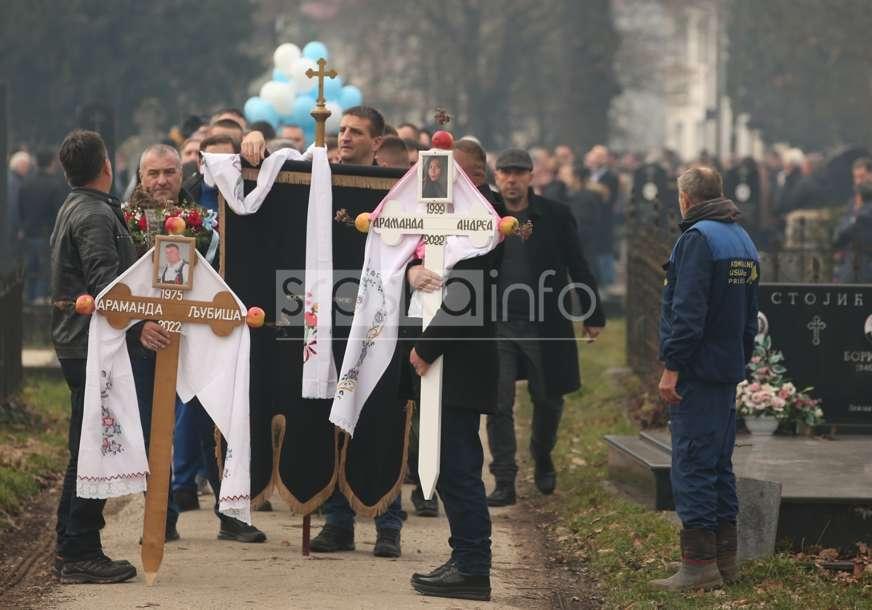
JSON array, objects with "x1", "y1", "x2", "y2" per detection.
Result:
[{"x1": 487, "y1": 149, "x2": 606, "y2": 506}]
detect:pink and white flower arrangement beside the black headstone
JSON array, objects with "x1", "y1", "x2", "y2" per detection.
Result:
[{"x1": 736, "y1": 335, "x2": 824, "y2": 434}]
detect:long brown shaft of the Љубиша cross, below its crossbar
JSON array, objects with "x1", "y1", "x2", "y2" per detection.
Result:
[{"x1": 142, "y1": 332, "x2": 180, "y2": 585}]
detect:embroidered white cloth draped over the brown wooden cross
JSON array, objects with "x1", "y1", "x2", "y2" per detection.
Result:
[{"x1": 76, "y1": 249, "x2": 251, "y2": 523}]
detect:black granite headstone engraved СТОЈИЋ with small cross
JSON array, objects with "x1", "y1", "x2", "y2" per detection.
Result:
[{"x1": 760, "y1": 284, "x2": 872, "y2": 426}]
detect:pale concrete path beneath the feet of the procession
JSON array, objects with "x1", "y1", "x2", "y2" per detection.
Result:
[{"x1": 44, "y1": 458, "x2": 553, "y2": 610}]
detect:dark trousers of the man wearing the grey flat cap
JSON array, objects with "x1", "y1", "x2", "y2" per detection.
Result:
[{"x1": 487, "y1": 321, "x2": 563, "y2": 484}]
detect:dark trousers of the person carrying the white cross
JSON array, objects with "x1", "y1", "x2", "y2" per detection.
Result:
[{"x1": 436, "y1": 405, "x2": 491, "y2": 576}]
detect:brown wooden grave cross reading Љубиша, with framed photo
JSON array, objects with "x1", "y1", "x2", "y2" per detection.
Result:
[{"x1": 96, "y1": 236, "x2": 245, "y2": 585}]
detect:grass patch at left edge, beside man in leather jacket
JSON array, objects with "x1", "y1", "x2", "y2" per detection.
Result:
[{"x1": 0, "y1": 375, "x2": 70, "y2": 529}]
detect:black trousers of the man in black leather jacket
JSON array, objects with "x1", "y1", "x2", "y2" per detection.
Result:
[{"x1": 55, "y1": 358, "x2": 106, "y2": 561}]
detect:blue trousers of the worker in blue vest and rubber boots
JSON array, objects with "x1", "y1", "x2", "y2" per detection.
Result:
[{"x1": 669, "y1": 379, "x2": 739, "y2": 531}]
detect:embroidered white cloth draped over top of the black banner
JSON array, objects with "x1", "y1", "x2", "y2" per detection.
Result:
[{"x1": 203, "y1": 146, "x2": 336, "y2": 398}]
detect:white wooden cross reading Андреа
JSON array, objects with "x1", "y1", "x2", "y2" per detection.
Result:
[{"x1": 371, "y1": 151, "x2": 497, "y2": 500}]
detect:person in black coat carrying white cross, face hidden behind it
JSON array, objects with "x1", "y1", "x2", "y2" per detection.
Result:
[{"x1": 407, "y1": 233, "x2": 503, "y2": 600}]
